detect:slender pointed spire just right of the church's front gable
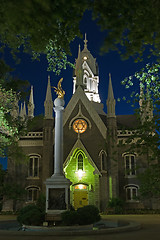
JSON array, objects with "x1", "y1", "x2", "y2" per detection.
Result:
[{"x1": 106, "y1": 73, "x2": 116, "y2": 117}]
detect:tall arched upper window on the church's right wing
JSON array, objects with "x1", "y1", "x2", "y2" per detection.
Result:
[{"x1": 124, "y1": 154, "x2": 136, "y2": 176}]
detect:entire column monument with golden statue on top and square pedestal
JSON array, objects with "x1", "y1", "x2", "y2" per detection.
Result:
[{"x1": 45, "y1": 78, "x2": 70, "y2": 219}]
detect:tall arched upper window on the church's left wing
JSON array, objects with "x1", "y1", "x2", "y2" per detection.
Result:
[{"x1": 28, "y1": 156, "x2": 39, "y2": 178}]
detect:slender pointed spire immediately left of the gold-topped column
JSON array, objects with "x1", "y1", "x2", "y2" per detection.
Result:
[{"x1": 44, "y1": 76, "x2": 53, "y2": 119}]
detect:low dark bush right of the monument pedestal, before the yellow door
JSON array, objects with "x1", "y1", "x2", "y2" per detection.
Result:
[{"x1": 61, "y1": 205, "x2": 100, "y2": 225}]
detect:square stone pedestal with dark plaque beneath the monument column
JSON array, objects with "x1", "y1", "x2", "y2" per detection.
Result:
[{"x1": 45, "y1": 174, "x2": 70, "y2": 216}]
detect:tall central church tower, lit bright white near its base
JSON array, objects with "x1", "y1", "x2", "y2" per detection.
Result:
[{"x1": 73, "y1": 34, "x2": 101, "y2": 103}]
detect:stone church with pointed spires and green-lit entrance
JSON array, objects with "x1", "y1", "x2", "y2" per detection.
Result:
[{"x1": 3, "y1": 37, "x2": 153, "y2": 211}]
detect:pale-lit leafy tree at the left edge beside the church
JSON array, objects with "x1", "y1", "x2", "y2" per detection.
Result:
[{"x1": 0, "y1": 60, "x2": 28, "y2": 157}]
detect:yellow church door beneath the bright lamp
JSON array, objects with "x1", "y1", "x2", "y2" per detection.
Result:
[{"x1": 73, "y1": 184, "x2": 88, "y2": 209}]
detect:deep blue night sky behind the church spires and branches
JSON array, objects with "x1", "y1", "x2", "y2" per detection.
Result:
[{"x1": 0, "y1": 12, "x2": 151, "y2": 169}]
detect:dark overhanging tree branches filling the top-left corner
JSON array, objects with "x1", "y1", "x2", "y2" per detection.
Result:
[{"x1": 0, "y1": 0, "x2": 89, "y2": 73}]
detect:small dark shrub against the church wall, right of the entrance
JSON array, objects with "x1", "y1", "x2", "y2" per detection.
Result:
[{"x1": 107, "y1": 198, "x2": 124, "y2": 214}]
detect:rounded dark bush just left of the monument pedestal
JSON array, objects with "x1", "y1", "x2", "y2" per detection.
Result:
[{"x1": 17, "y1": 204, "x2": 44, "y2": 225}]
